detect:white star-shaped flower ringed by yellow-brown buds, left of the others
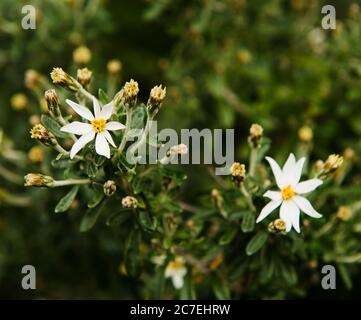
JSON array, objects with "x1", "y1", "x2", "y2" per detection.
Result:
[{"x1": 61, "y1": 98, "x2": 125, "y2": 159}]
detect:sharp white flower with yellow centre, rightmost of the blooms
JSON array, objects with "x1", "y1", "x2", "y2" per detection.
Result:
[{"x1": 257, "y1": 153, "x2": 322, "y2": 232}]
